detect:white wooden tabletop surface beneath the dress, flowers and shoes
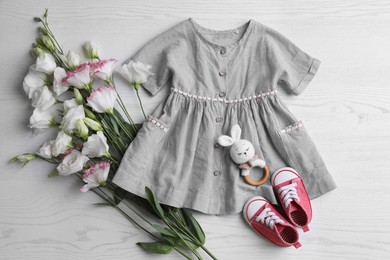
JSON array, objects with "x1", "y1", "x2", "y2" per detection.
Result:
[{"x1": 0, "y1": 0, "x2": 390, "y2": 260}]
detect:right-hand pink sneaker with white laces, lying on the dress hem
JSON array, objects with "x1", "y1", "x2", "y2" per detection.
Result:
[{"x1": 271, "y1": 167, "x2": 312, "y2": 232}]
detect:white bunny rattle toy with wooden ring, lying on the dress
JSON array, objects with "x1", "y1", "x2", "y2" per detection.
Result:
[{"x1": 218, "y1": 124, "x2": 269, "y2": 186}]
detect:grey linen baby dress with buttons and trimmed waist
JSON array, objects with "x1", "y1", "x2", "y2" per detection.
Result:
[{"x1": 113, "y1": 18, "x2": 336, "y2": 215}]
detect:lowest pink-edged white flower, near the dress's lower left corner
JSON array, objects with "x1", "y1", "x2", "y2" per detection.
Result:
[{"x1": 80, "y1": 161, "x2": 111, "y2": 192}]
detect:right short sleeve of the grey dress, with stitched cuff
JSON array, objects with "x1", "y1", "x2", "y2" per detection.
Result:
[{"x1": 265, "y1": 27, "x2": 321, "y2": 95}]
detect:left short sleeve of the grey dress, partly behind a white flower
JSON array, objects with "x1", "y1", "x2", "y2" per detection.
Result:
[{"x1": 129, "y1": 26, "x2": 178, "y2": 96}]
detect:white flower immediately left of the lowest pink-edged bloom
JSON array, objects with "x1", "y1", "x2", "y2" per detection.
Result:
[{"x1": 57, "y1": 149, "x2": 89, "y2": 176}]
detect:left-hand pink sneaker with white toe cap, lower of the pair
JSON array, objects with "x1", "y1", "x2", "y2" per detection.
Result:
[{"x1": 243, "y1": 197, "x2": 301, "y2": 248}]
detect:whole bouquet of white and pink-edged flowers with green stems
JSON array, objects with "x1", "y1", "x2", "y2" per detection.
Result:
[{"x1": 10, "y1": 10, "x2": 216, "y2": 259}]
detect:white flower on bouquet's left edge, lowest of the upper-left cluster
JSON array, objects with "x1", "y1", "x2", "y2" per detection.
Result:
[{"x1": 29, "y1": 103, "x2": 63, "y2": 132}]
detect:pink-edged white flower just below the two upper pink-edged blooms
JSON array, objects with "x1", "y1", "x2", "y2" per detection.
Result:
[{"x1": 87, "y1": 86, "x2": 116, "y2": 113}]
